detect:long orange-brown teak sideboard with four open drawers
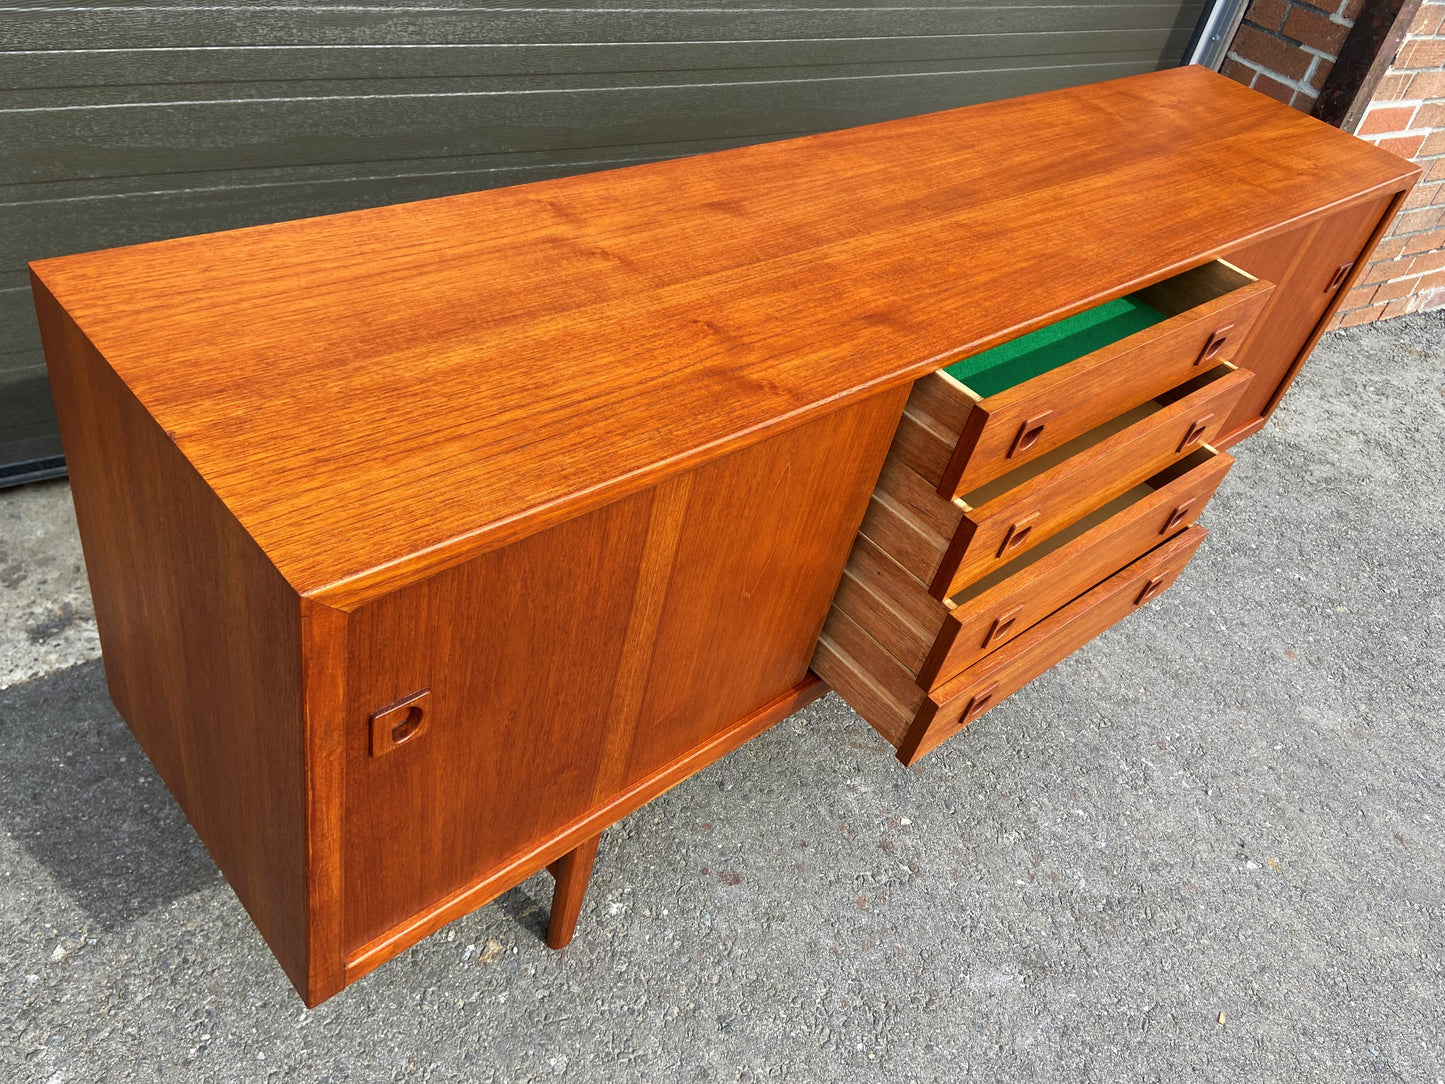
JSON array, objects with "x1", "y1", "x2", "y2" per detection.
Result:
[{"x1": 32, "y1": 68, "x2": 1416, "y2": 1005}]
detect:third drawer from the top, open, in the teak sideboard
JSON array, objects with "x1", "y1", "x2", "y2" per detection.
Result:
[{"x1": 825, "y1": 448, "x2": 1234, "y2": 691}]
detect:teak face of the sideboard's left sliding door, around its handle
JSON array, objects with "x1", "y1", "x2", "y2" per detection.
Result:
[{"x1": 341, "y1": 386, "x2": 907, "y2": 957}]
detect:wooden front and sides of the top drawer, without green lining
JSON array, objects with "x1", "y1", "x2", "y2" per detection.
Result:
[{"x1": 894, "y1": 260, "x2": 1273, "y2": 496}]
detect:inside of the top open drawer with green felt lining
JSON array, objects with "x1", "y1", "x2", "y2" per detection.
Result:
[{"x1": 944, "y1": 260, "x2": 1254, "y2": 399}]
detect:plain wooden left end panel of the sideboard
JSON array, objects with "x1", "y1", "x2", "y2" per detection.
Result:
[{"x1": 35, "y1": 283, "x2": 308, "y2": 991}]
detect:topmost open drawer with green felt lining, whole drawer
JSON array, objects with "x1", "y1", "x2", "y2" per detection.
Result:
[{"x1": 893, "y1": 260, "x2": 1273, "y2": 497}]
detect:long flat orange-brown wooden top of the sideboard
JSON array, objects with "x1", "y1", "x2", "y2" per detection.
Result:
[{"x1": 32, "y1": 68, "x2": 1416, "y2": 608}]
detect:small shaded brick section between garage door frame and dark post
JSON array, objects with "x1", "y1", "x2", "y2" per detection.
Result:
[{"x1": 1220, "y1": 0, "x2": 1363, "y2": 113}]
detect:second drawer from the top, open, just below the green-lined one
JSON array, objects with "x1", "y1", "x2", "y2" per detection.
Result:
[{"x1": 861, "y1": 364, "x2": 1251, "y2": 600}]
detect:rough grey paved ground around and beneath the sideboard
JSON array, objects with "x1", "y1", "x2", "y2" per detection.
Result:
[{"x1": 0, "y1": 312, "x2": 1445, "y2": 1084}]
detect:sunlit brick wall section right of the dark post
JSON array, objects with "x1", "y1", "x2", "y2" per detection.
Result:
[{"x1": 1334, "y1": 0, "x2": 1445, "y2": 327}]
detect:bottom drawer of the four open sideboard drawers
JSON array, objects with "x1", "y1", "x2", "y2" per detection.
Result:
[{"x1": 812, "y1": 525, "x2": 1208, "y2": 765}]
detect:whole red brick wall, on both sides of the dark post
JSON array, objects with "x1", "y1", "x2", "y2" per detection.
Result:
[{"x1": 1221, "y1": 0, "x2": 1445, "y2": 327}]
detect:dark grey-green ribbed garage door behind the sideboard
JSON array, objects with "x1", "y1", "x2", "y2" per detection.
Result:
[{"x1": 0, "y1": 0, "x2": 1204, "y2": 479}]
